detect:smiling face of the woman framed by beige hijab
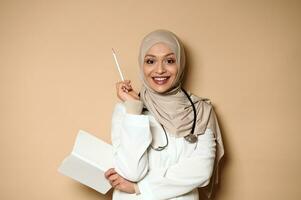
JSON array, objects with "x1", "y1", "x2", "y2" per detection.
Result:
[{"x1": 143, "y1": 43, "x2": 178, "y2": 93}]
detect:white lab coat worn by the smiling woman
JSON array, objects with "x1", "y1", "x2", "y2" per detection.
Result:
[{"x1": 112, "y1": 103, "x2": 216, "y2": 200}]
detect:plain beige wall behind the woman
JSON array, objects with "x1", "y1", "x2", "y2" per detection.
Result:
[{"x1": 0, "y1": 0, "x2": 301, "y2": 200}]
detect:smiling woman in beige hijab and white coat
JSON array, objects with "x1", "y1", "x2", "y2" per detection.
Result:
[{"x1": 105, "y1": 30, "x2": 224, "y2": 200}]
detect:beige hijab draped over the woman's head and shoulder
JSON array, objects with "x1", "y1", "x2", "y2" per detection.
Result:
[{"x1": 138, "y1": 30, "x2": 224, "y2": 198}]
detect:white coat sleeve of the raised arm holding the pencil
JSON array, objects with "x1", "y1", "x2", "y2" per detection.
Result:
[{"x1": 111, "y1": 103, "x2": 152, "y2": 182}]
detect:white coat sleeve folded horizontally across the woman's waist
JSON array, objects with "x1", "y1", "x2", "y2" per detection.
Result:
[{"x1": 138, "y1": 129, "x2": 216, "y2": 200}]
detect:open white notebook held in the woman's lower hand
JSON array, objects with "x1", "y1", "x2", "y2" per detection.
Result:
[{"x1": 58, "y1": 130, "x2": 113, "y2": 194}]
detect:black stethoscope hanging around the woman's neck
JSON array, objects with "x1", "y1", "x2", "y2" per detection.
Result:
[{"x1": 141, "y1": 88, "x2": 198, "y2": 151}]
